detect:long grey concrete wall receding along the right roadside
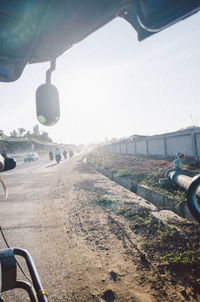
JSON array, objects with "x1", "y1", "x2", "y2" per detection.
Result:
[{"x1": 100, "y1": 127, "x2": 200, "y2": 159}]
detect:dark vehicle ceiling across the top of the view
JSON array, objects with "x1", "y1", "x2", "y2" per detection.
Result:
[{"x1": 0, "y1": 0, "x2": 200, "y2": 82}]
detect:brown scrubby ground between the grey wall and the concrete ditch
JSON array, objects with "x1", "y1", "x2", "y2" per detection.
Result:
[{"x1": 87, "y1": 152, "x2": 195, "y2": 204}]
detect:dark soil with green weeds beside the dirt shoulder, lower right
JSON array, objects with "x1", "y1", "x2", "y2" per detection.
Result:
[{"x1": 96, "y1": 195, "x2": 200, "y2": 295}]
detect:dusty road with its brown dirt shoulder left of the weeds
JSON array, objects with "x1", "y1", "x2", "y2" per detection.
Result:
[{"x1": 0, "y1": 156, "x2": 197, "y2": 302}]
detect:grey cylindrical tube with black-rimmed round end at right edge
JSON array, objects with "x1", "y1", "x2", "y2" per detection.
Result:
[{"x1": 165, "y1": 169, "x2": 200, "y2": 223}]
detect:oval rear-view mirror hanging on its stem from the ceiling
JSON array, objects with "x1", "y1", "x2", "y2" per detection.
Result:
[{"x1": 36, "y1": 59, "x2": 60, "y2": 126}]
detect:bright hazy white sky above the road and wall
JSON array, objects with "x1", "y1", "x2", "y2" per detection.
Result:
[{"x1": 0, "y1": 13, "x2": 200, "y2": 144}]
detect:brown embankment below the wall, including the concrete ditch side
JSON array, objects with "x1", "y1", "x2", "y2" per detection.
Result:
[{"x1": 87, "y1": 152, "x2": 198, "y2": 221}]
